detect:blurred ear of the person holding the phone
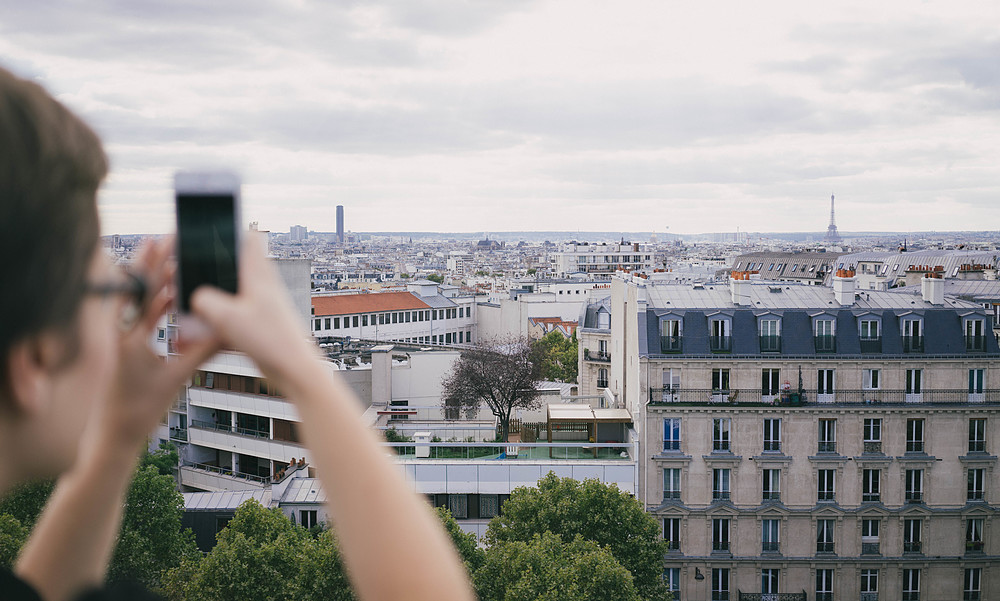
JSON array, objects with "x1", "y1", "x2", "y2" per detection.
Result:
[{"x1": 7, "y1": 335, "x2": 60, "y2": 416}]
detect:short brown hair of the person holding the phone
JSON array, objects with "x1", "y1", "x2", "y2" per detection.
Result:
[{"x1": 0, "y1": 68, "x2": 108, "y2": 399}]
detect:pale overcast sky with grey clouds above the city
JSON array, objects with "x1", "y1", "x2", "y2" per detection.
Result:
[{"x1": 0, "y1": 0, "x2": 1000, "y2": 233}]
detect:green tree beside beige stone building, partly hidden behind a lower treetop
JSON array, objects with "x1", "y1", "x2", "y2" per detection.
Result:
[{"x1": 485, "y1": 472, "x2": 669, "y2": 600}]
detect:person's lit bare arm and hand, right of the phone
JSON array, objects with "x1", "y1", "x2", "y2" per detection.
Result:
[{"x1": 192, "y1": 237, "x2": 474, "y2": 601}]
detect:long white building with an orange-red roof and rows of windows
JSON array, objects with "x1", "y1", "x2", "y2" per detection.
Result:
[{"x1": 310, "y1": 280, "x2": 478, "y2": 344}]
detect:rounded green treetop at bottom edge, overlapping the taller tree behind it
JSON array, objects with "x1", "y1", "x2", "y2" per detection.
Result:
[{"x1": 475, "y1": 532, "x2": 642, "y2": 601}]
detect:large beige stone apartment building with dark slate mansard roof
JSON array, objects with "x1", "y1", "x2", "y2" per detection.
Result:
[{"x1": 600, "y1": 270, "x2": 1000, "y2": 601}]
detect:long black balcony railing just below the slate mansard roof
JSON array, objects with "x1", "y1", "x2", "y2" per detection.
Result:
[{"x1": 648, "y1": 388, "x2": 1000, "y2": 406}]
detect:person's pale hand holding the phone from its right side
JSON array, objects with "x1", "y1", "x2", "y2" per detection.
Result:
[{"x1": 191, "y1": 234, "x2": 317, "y2": 387}]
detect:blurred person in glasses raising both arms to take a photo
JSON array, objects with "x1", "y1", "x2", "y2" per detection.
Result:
[{"x1": 0, "y1": 68, "x2": 473, "y2": 601}]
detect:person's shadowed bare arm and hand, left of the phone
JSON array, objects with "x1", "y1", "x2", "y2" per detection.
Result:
[{"x1": 15, "y1": 241, "x2": 216, "y2": 601}]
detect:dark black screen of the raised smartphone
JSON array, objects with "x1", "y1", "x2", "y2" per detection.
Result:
[{"x1": 177, "y1": 194, "x2": 237, "y2": 313}]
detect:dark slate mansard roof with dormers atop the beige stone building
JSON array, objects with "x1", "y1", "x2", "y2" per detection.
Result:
[{"x1": 639, "y1": 283, "x2": 1000, "y2": 358}]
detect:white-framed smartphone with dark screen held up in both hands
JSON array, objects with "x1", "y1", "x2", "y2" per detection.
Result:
[{"x1": 174, "y1": 171, "x2": 242, "y2": 333}]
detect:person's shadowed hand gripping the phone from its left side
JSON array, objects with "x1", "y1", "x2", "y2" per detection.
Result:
[{"x1": 94, "y1": 238, "x2": 219, "y2": 449}]
